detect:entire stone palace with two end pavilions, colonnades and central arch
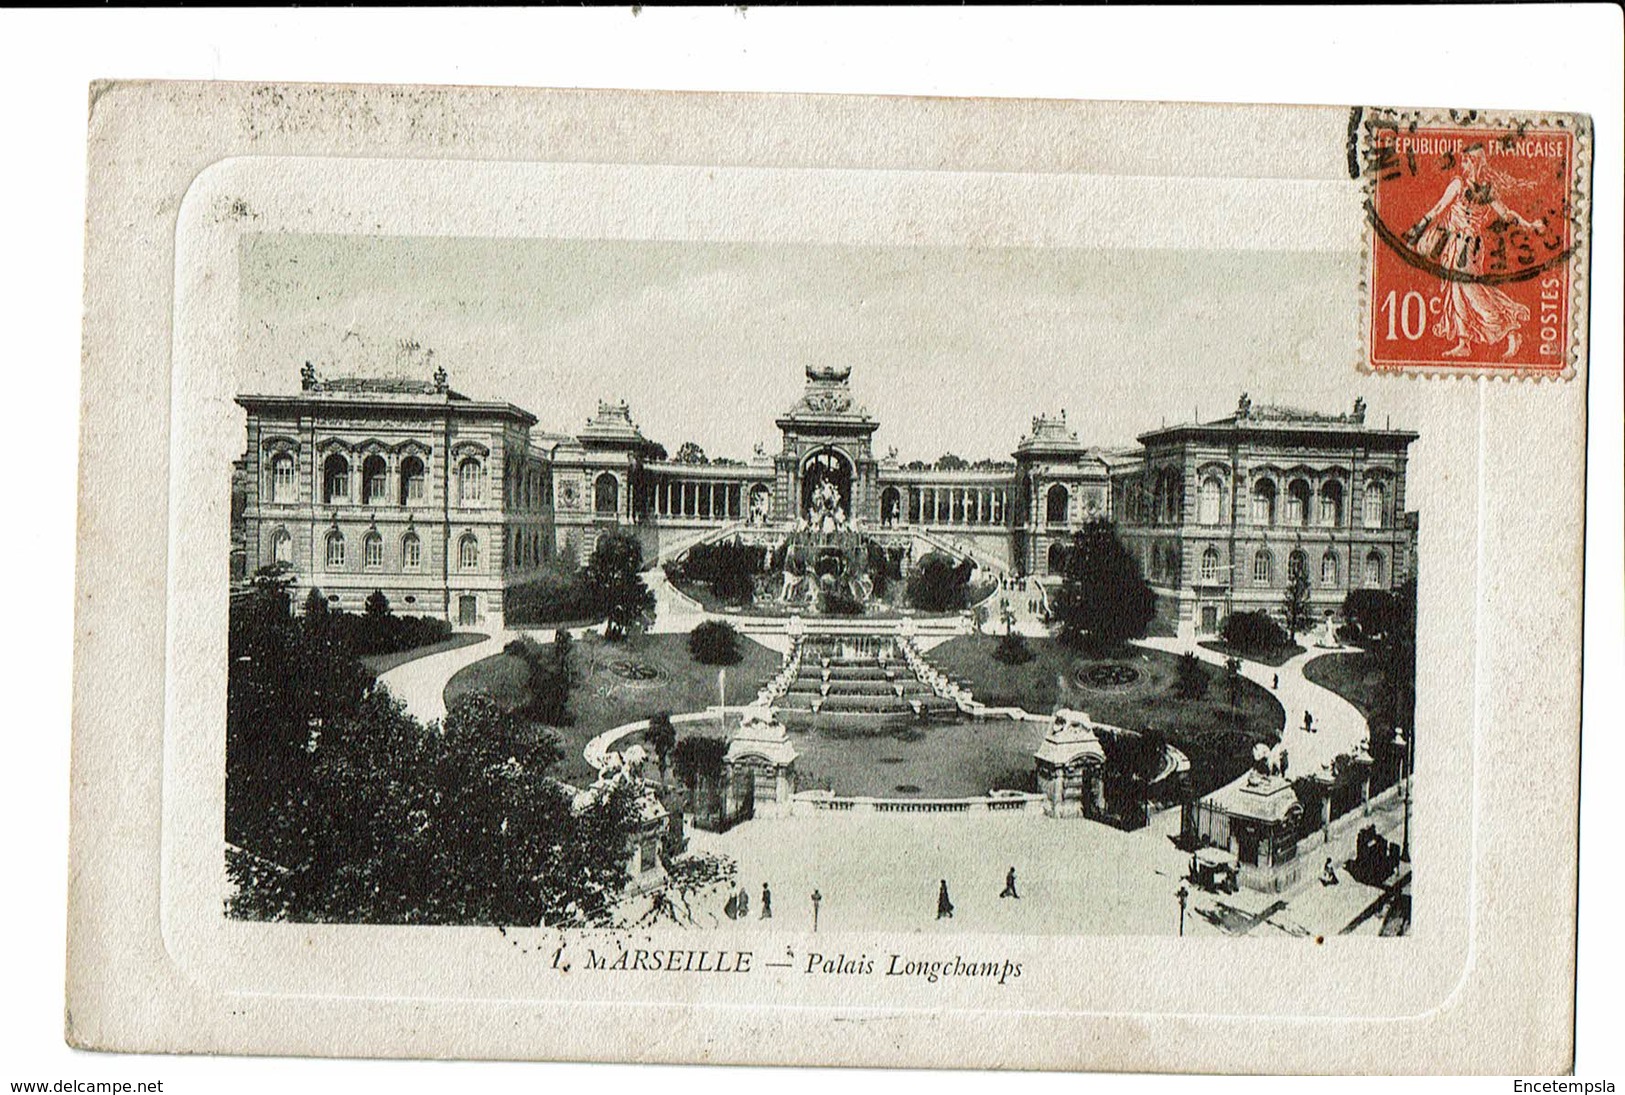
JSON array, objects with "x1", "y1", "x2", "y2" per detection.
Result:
[{"x1": 234, "y1": 364, "x2": 1417, "y2": 635}]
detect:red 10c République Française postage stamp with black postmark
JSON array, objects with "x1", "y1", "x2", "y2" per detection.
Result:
[{"x1": 1363, "y1": 114, "x2": 1589, "y2": 377}]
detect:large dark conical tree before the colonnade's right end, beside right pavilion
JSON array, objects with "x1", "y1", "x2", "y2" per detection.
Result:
[{"x1": 1050, "y1": 520, "x2": 1157, "y2": 650}]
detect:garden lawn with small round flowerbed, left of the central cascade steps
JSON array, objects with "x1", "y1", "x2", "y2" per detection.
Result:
[{"x1": 445, "y1": 634, "x2": 782, "y2": 785}]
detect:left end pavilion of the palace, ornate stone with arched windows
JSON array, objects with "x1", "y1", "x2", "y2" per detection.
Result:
[{"x1": 237, "y1": 366, "x2": 554, "y2": 627}]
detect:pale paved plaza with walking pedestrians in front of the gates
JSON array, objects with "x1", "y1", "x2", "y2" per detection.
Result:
[{"x1": 689, "y1": 779, "x2": 1402, "y2": 937}]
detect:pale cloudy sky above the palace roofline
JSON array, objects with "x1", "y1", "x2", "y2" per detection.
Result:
[{"x1": 239, "y1": 234, "x2": 1406, "y2": 460}]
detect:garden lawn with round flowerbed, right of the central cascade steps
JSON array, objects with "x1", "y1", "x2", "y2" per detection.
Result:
[{"x1": 926, "y1": 635, "x2": 1287, "y2": 794}]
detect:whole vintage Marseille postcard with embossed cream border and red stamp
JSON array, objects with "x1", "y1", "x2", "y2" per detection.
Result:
[{"x1": 67, "y1": 83, "x2": 1591, "y2": 1072}]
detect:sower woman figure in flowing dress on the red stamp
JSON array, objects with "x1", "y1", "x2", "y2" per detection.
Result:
[{"x1": 1406, "y1": 145, "x2": 1545, "y2": 357}]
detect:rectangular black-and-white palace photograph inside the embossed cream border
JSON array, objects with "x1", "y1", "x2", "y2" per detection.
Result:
[{"x1": 224, "y1": 234, "x2": 1428, "y2": 937}]
